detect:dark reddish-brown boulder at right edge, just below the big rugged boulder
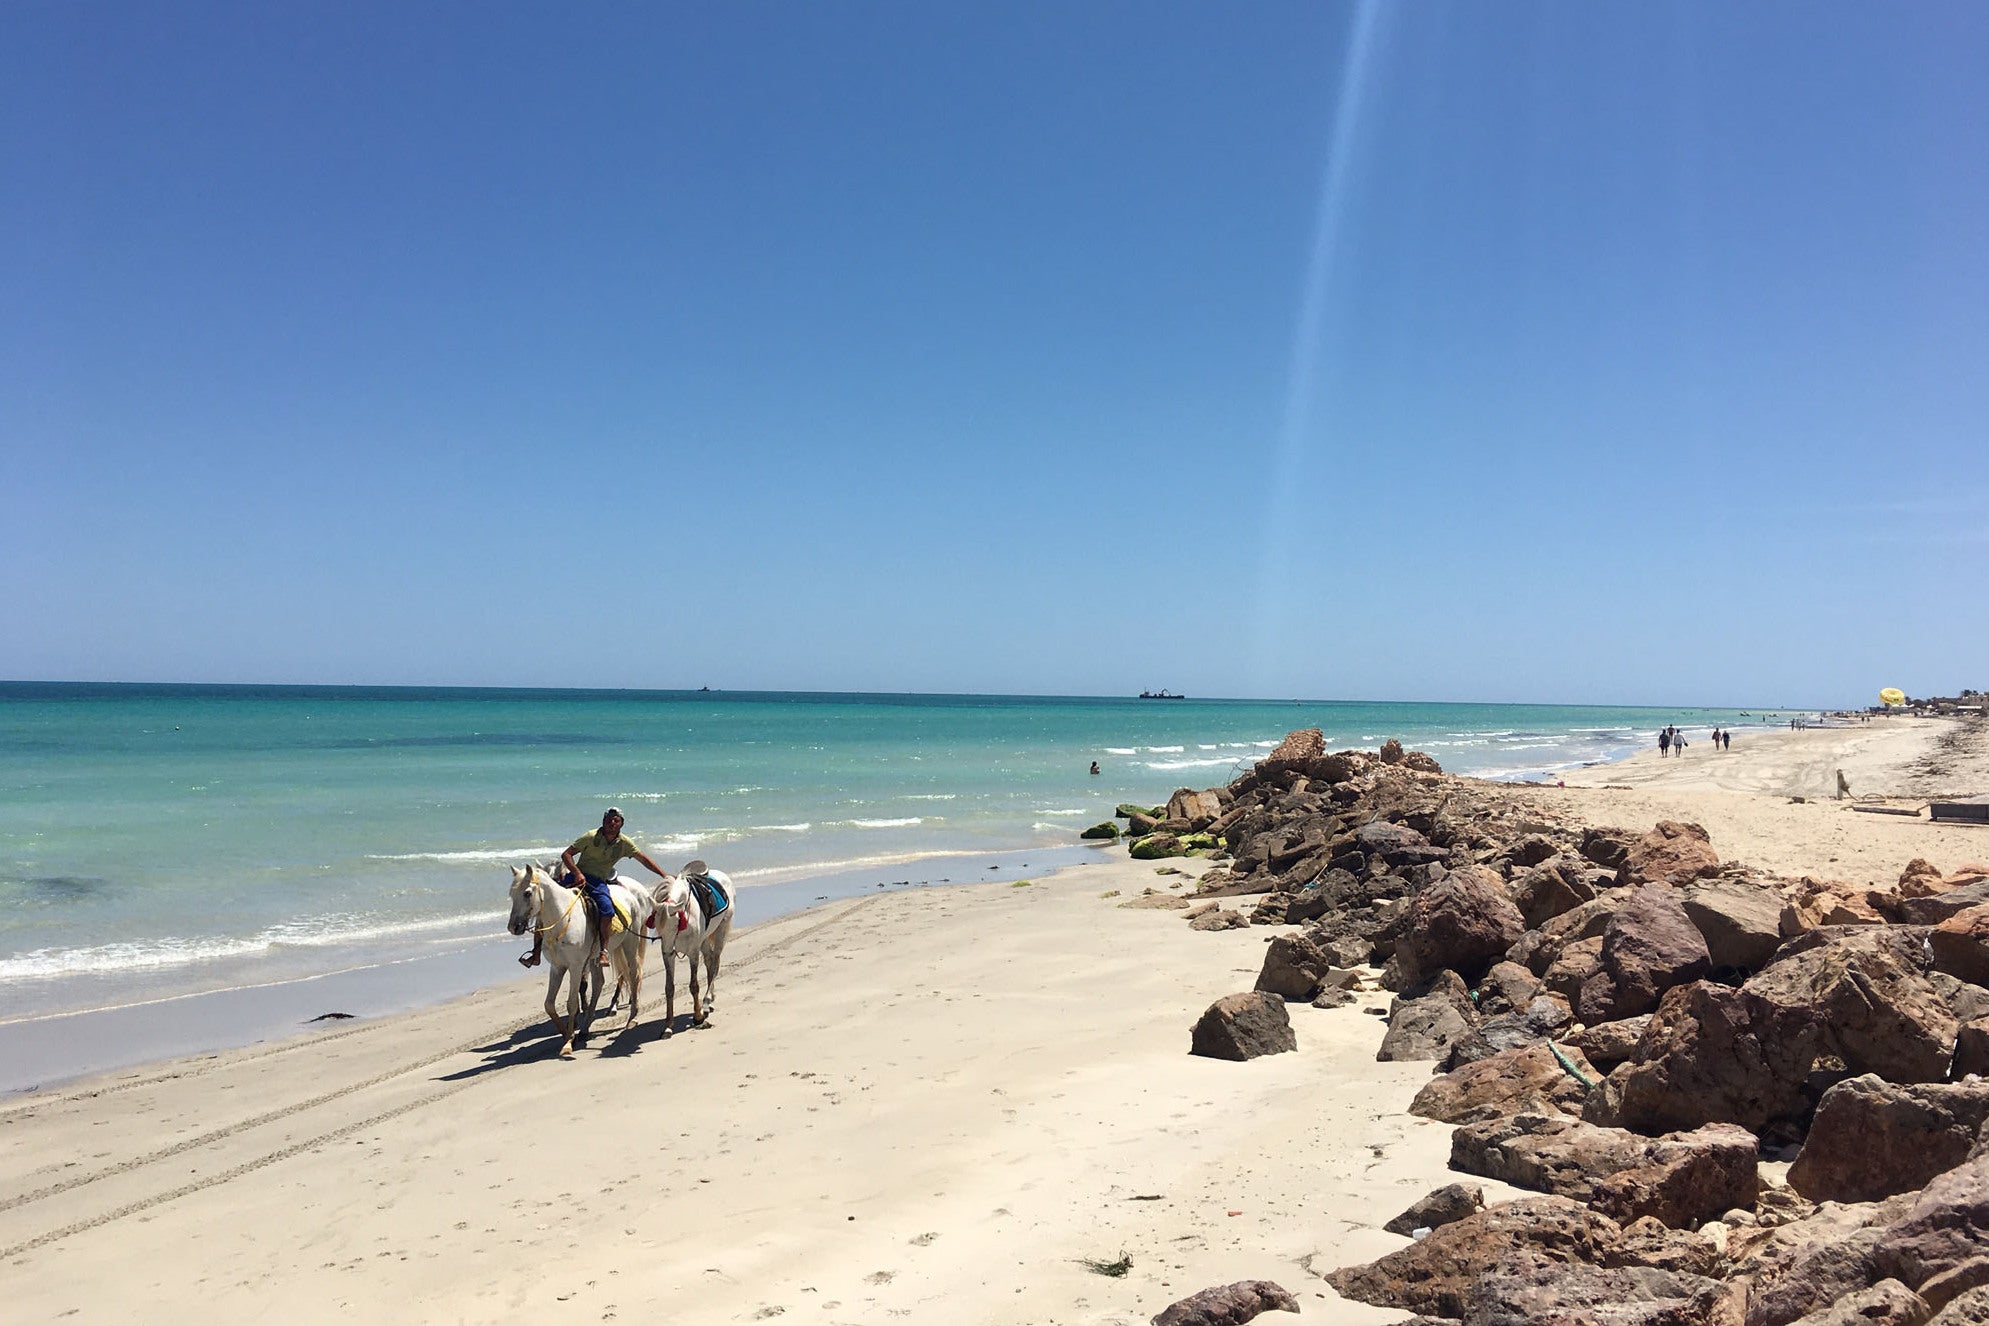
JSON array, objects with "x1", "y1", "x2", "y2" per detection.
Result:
[{"x1": 1788, "y1": 1074, "x2": 1989, "y2": 1201}]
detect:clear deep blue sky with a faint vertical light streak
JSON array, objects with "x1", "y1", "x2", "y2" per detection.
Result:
[{"x1": 0, "y1": 2, "x2": 1989, "y2": 706}]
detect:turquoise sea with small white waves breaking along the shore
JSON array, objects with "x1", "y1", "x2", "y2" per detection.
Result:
[{"x1": 0, "y1": 682, "x2": 1786, "y2": 1018}]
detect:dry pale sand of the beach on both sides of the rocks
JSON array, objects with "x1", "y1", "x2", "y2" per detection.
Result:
[{"x1": 0, "y1": 722, "x2": 1989, "y2": 1324}]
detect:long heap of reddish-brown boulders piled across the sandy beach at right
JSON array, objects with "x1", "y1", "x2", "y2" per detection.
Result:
[{"x1": 1130, "y1": 730, "x2": 1989, "y2": 1326}]
